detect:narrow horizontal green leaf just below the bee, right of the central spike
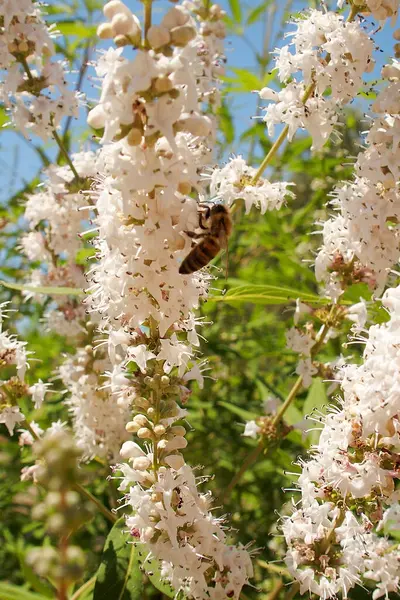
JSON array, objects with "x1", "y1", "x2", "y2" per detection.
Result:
[{"x1": 208, "y1": 285, "x2": 329, "y2": 306}]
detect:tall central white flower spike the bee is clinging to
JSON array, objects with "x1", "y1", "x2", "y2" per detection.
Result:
[{"x1": 87, "y1": 0, "x2": 252, "y2": 599}]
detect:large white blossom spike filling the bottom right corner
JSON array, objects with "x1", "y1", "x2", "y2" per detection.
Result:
[{"x1": 282, "y1": 286, "x2": 400, "y2": 599}]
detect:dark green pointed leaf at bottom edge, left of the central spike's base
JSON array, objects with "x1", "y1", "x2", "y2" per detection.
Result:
[{"x1": 93, "y1": 517, "x2": 143, "y2": 600}]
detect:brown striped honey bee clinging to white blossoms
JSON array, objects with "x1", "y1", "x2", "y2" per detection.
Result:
[{"x1": 179, "y1": 204, "x2": 232, "y2": 275}]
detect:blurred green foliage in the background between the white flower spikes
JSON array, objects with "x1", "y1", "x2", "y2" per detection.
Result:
[{"x1": 0, "y1": 0, "x2": 383, "y2": 600}]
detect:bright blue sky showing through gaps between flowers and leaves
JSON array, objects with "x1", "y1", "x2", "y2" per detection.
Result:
[{"x1": 0, "y1": 0, "x2": 393, "y2": 203}]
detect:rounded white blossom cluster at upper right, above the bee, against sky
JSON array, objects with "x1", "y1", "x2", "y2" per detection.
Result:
[{"x1": 259, "y1": 10, "x2": 374, "y2": 150}]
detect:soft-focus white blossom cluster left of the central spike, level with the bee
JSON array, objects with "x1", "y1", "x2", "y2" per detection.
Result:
[{"x1": 20, "y1": 152, "x2": 96, "y2": 338}]
